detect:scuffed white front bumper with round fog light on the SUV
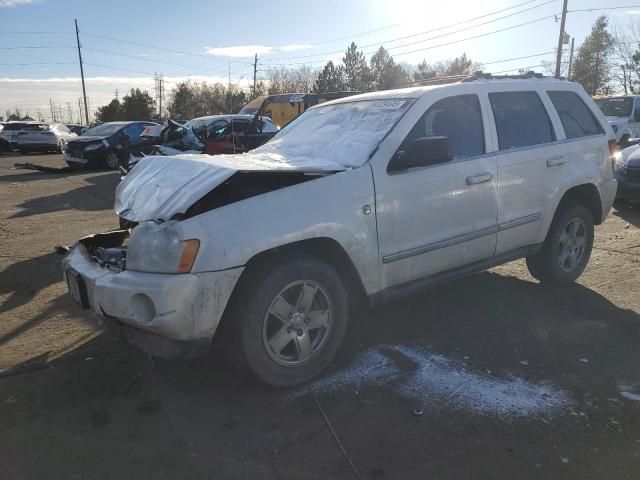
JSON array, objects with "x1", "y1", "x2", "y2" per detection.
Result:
[{"x1": 62, "y1": 240, "x2": 244, "y2": 357}]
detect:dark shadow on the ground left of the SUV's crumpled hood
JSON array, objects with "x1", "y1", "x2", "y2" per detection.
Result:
[{"x1": 10, "y1": 172, "x2": 120, "y2": 218}]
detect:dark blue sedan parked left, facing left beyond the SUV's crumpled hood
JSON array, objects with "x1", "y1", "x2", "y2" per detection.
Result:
[{"x1": 64, "y1": 122, "x2": 158, "y2": 169}]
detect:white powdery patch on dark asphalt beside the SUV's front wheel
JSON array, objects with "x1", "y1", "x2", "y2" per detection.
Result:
[{"x1": 292, "y1": 345, "x2": 570, "y2": 417}]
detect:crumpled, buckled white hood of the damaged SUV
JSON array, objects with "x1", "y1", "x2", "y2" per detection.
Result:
[{"x1": 114, "y1": 152, "x2": 345, "y2": 222}]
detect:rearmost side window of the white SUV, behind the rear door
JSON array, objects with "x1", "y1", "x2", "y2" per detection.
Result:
[{"x1": 547, "y1": 92, "x2": 604, "y2": 138}]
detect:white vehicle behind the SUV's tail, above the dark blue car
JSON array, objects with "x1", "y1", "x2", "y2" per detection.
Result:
[{"x1": 595, "y1": 95, "x2": 640, "y2": 148}]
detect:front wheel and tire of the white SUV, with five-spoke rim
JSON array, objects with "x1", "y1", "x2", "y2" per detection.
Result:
[{"x1": 227, "y1": 257, "x2": 349, "y2": 387}]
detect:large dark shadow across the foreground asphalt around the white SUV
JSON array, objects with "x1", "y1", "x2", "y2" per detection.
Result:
[{"x1": 0, "y1": 273, "x2": 640, "y2": 479}]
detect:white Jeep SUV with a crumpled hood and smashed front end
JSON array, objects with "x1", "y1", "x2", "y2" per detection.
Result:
[{"x1": 63, "y1": 76, "x2": 616, "y2": 386}]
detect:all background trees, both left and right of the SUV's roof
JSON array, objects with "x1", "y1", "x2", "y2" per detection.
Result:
[{"x1": 96, "y1": 15, "x2": 640, "y2": 121}]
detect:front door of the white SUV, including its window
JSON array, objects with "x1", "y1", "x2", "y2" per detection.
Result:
[{"x1": 375, "y1": 94, "x2": 498, "y2": 289}]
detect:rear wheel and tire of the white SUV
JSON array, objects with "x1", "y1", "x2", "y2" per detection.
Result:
[{"x1": 527, "y1": 204, "x2": 593, "y2": 285}]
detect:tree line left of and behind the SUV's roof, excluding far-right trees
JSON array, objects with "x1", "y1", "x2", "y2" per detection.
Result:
[{"x1": 95, "y1": 42, "x2": 480, "y2": 122}]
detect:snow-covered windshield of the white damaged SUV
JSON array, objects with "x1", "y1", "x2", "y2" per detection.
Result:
[{"x1": 254, "y1": 99, "x2": 411, "y2": 168}]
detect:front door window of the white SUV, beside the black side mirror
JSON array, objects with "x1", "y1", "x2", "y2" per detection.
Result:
[{"x1": 399, "y1": 95, "x2": 485, "y2": 159}]
